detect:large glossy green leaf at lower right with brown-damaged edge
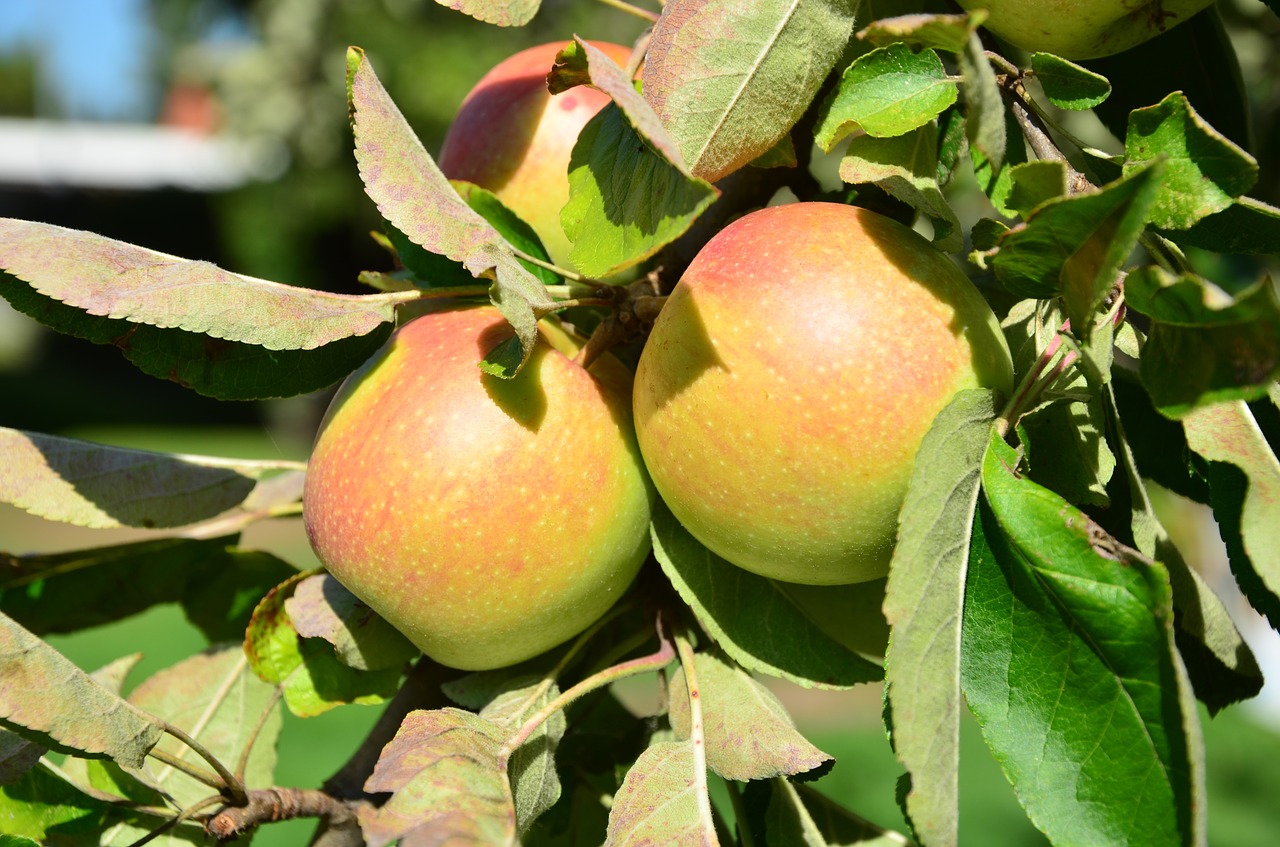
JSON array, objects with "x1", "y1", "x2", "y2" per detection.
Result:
[{"x1": 961, "y1": 434, "x2": 1204, "y2": 844}]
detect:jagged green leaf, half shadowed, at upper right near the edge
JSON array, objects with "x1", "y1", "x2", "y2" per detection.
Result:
[{"x1": 1124, "y1": 91, "x2": 1258, "y2": 229}]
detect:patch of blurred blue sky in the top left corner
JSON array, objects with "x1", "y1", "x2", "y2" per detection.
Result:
[{"x1": 0, "y1": 0, "x2": 152, "y2": 120}]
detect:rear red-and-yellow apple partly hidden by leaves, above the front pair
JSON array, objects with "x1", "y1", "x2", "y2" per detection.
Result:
[{"x1": 439, "y1": 41, "x2": 631, "y2": 267}]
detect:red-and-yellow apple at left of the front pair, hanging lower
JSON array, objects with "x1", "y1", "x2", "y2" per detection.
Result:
[{"x1": 303, "y1": 307, "x2": 653, "y2": 670}]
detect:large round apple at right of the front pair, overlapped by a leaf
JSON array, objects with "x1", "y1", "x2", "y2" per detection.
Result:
[{"x1": 634, "y1": 202, "x2": 1012, "y2": 585}]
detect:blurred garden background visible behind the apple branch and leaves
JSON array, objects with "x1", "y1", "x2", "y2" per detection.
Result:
[{"x1": 0, "y1": 0, "x2": 1280, "y2": 847}]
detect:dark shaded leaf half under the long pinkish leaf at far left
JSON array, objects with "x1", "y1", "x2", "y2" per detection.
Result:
[{"x1": 0, "y1": 273, "x2": 392, "y2": 400}]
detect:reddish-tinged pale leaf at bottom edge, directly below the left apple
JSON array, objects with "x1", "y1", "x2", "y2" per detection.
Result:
[{"x1": 360, "y1": 709, "x2": 517, "y2": 847}]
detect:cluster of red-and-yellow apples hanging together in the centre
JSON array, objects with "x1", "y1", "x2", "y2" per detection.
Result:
[{"x1": 305, "y1": 45, "x2": 1012, "y2": 669}]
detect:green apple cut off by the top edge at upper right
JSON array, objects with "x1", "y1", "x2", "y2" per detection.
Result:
[{"x1": 960, "y1": 0, "x2": 1213, "y2": 59}]
